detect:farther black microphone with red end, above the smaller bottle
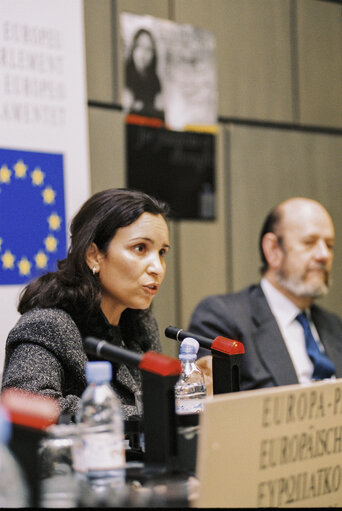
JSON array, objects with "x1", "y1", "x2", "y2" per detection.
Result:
[{"x1": 165, "y1": 326, "x2": 245, "y2": 355}]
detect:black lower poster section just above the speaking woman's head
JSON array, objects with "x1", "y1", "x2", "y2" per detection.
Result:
[{"x1": 126, "y1": 124, "x2": 216, "y2": 220}]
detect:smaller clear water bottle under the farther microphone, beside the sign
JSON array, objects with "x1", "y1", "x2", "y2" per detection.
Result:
[{"x1": 175, "y1": 337, "x2": 206, "y2": 415}]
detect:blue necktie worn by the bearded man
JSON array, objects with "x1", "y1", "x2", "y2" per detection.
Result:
[{"x1": 296, "y1": 312, "x2": 335, "y2": 380}]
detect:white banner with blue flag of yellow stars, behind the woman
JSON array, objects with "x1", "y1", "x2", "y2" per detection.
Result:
[{"x1": 0, "y1": 0, "x2": 90, "y2": 373}]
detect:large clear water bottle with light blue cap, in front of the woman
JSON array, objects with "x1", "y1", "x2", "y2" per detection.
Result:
[{"x1": 73, "y1": 361, "x2": 125, "y2": 506}]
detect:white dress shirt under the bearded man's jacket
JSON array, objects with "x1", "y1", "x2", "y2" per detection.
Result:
[{"x1": 260, "y1": 278, "x2": 324, "y2": 383}]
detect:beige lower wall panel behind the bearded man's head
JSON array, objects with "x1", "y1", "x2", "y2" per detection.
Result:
[{"x1": 227, "y1": 127, "x2": 342, "y2": 314}]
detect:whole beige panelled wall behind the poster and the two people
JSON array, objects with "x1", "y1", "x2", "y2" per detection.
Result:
[{"x1": 84, "y1": 0, "x2": 342, "y2": 355}]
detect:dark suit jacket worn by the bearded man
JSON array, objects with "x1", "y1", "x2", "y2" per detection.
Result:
[{"x1": 189, "y1": 285, "x2": 342, "y2": 390}]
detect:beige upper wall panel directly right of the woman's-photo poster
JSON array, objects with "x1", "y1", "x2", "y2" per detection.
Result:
[{"x1": 174, "y1": 0, "x2": 293, "y2": 121}]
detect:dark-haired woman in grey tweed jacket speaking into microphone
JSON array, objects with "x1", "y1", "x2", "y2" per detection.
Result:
[{"x1": 2, "y1": 189, "x2": 169, "y2": 418}]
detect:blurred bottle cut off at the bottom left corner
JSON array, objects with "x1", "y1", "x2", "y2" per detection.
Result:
[{"x1": 0, "y1": 407, "x2": 29, "y2": 508}]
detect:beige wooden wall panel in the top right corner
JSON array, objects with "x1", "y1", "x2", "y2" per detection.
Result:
[{"x1": 297, "y1": 0, "x2": 342, "y2": 128}]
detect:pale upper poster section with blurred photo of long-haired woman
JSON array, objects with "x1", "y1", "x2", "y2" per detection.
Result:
[{"x1": 120, "y1": 12, "x2": 217, "y2": 130}]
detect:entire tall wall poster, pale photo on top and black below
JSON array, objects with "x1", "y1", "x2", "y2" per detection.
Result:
[{"x1": 121, "y1": 13, "x2": 217, "y2": 220}]
